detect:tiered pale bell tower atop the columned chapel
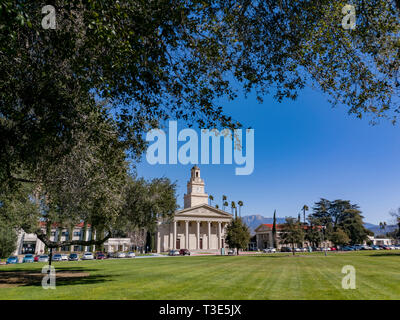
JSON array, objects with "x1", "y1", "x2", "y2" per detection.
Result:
[{"x1": 184, "y1": 165, "x2": 208, "y2": 209}]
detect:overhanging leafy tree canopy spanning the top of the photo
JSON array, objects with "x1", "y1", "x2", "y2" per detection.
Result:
[{"x1": 0, "y1": 0, "x2": 400, "y2": 191}]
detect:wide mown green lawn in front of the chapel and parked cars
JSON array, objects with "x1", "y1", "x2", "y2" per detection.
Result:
[{"x1": 0, "y1": 251, "x2": 400, "y2": 300}]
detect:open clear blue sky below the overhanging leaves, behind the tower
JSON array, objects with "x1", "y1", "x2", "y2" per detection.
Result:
[{"x1": 137, "y1": 89, "x2": 400, "y2": 223}]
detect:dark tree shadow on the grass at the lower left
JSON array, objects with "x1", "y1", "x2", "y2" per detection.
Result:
[{"x1": 0, "y1": 267, "x2": 115, "y2": 288}]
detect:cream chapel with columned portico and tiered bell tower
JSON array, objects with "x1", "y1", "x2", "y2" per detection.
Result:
[{"x1": 156, "y1": 166, "x2": 232, "y2": 252}]
